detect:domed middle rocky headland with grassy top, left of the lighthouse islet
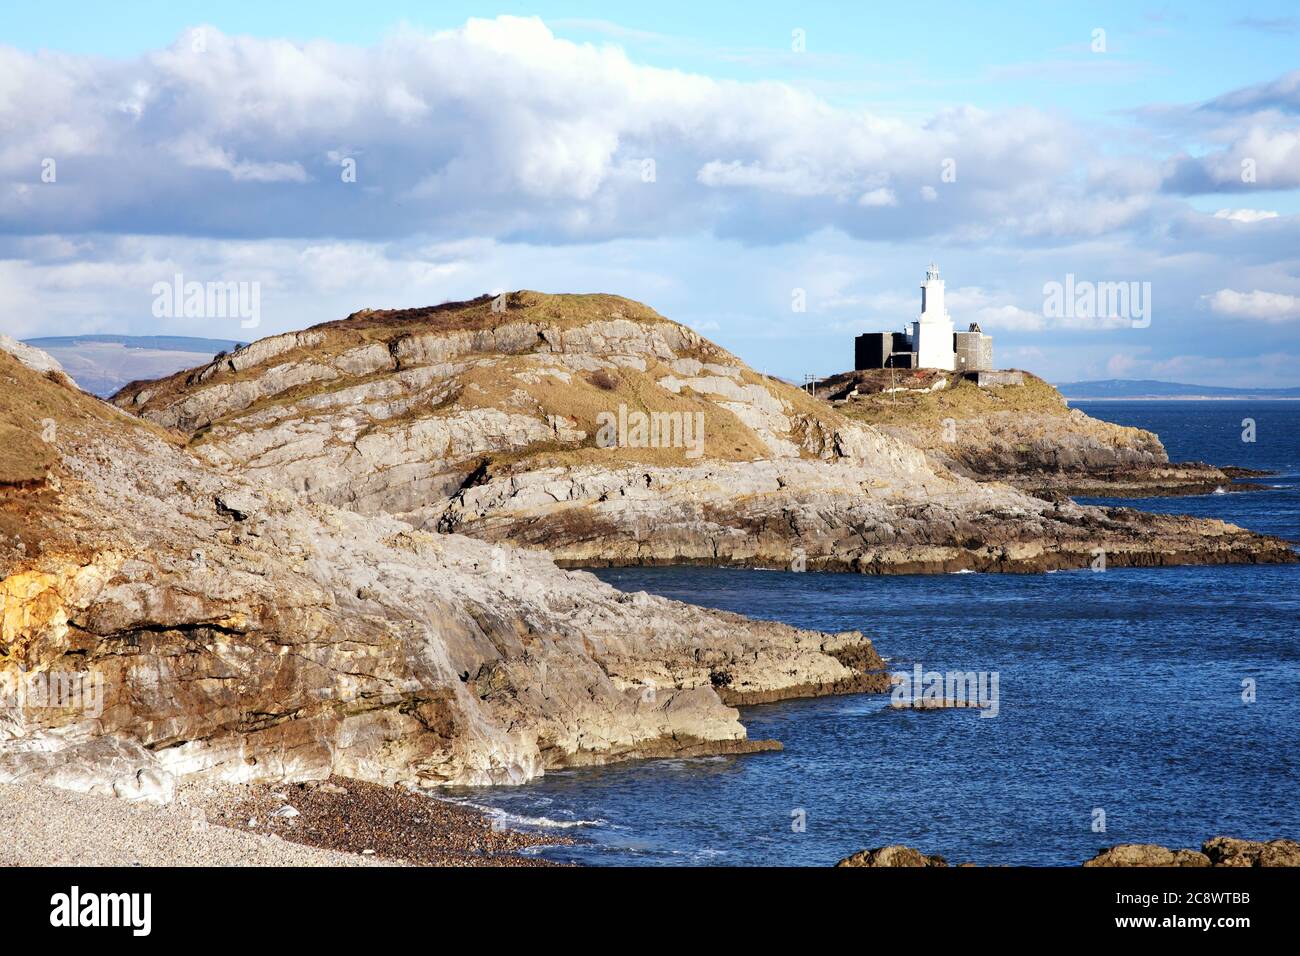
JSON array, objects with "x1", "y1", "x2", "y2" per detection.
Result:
[{"x1": 113, "y1": 293, "x2": 1294, "y2": 572}]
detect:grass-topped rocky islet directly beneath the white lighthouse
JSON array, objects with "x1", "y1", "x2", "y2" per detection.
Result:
[{"x1": 816, "y1": 369, "x2": 1240, "y2": 498}]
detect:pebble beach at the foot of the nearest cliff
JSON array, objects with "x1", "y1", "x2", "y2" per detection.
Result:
[{"x1": 0, "y1": 778, "x2": 563, "y2": 866}]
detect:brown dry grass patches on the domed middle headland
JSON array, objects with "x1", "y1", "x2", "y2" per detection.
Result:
[{"x1": 126, "y1": 291, "x2": 842, "y2": 468}]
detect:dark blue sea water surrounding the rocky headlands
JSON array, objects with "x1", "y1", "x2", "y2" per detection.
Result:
[{"x1": 449, "y1": 402, "x2": 1300, "y2": 865}]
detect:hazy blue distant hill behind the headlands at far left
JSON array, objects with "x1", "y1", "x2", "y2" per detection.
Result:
[{"x1": 26, "y1": 336, "x2": 241, "y2": 398}]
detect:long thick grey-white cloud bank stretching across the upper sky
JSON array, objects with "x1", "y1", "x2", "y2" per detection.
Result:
[{"x1": 0, "y1": 17, "x2": 1128, "y2": 242}]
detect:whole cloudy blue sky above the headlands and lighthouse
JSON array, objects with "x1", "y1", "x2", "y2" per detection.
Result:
[{"x1": 0, "y1": 0, "x2": 1300, "y2": 386}]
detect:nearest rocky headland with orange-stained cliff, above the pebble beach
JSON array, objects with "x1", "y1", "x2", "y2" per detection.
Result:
[{"x1": 0, "y1": 346, "x2": 888, "y2": 800}]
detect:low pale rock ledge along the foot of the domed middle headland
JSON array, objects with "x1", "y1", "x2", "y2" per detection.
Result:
[{"x1": 434, "y1": 459, "x2": 1294, "y2": 574}]
